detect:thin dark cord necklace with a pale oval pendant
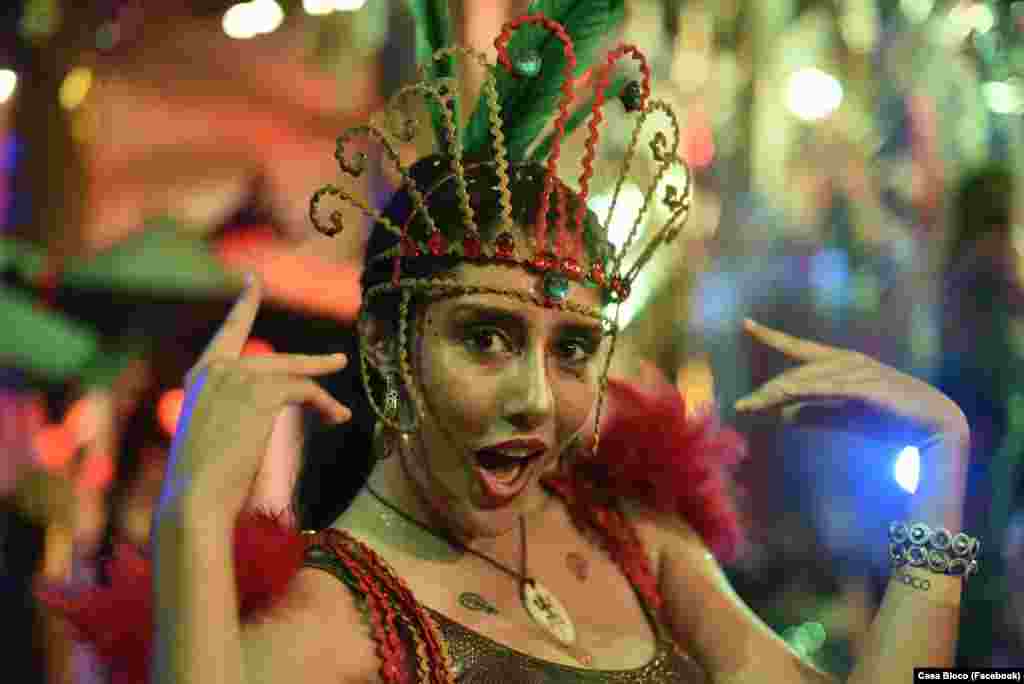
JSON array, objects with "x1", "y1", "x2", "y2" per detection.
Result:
[{"x1": 366, "y1": 482, "x2": 591, "y2": 665}]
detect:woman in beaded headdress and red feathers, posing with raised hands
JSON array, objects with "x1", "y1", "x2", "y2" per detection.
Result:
[{"x1": 44, "y1": 6, "x2": 973, "y2": 684}]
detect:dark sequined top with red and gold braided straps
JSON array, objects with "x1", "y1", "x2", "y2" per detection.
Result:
[{"x1": 305, "y1": 479, "x2": 710, "y2": 684}]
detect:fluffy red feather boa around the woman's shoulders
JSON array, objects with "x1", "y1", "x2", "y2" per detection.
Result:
[{"x1": 36, "y1": 370, "x2": 744, "y2": 684}]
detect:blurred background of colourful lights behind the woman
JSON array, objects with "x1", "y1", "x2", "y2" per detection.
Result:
[{"x1": 6, "y1": 0, "x2": 1024, "y2": 684}]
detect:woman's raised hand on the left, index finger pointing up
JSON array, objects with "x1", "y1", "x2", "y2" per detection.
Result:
[{"x1": 156, "y1": 275, "x2": 351, "y2": 528}]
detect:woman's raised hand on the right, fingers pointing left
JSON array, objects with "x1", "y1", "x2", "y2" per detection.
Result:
[{"x1": 735, "y1": 318, "x2": 969, "y2": 436}]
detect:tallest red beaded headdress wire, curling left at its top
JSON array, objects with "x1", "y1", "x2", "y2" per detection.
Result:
[{"x1": 495, "y1": 14, "x2": 577, "y2": 264}]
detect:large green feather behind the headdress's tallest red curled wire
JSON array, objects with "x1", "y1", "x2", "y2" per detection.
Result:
[{"x1": 463, "y1": 0, "x2": 625, "y2": 161}]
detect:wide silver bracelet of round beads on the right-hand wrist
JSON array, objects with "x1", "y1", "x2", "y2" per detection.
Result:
[{"x1": 889, "y1": 522, "x2": 981, "y2": 580}]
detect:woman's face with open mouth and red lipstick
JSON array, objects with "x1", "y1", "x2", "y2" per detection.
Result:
[{"x1": 407, "y1": 265, "x2": 608, "y2": 540}]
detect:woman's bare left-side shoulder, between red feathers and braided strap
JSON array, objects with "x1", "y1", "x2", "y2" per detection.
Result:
[{"x1": 243, "y1": 567, "x2": 380, "y2": 684}]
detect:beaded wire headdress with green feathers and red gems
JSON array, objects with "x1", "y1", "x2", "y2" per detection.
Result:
[{"x1": 310, "y1": 0, "x2": 690, "y2": 448}]
